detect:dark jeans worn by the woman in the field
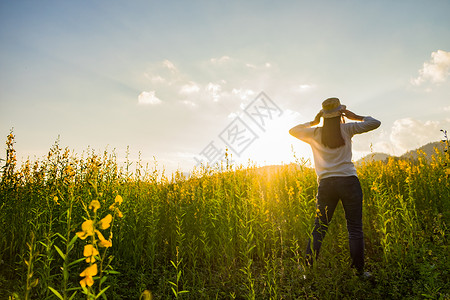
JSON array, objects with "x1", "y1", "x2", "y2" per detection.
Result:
[{"x1": 306, "y1": 176, "x2": 364, "y2": 272}]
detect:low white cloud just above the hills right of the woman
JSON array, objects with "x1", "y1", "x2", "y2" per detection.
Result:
[{"x1": 390, "y1": 118, "x2": 450, "y2": 153}]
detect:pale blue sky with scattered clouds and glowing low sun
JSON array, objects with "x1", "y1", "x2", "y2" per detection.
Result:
[{"x1": 0, "y1": 0, "x2": 450, "y2": 173}]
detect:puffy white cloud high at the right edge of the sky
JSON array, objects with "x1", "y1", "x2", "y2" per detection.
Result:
[{"x1": 411, "y1": 50, "x2": 450, "y2": 85}]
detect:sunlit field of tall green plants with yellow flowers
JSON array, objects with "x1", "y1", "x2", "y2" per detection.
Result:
[{"x1": 0, "y1": 134, "x2": 450, "y2": 299}]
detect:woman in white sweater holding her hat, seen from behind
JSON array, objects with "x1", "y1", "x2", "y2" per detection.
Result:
[{"x1": 289, "y1": 98, "x2": 381, "y2": 277}]
